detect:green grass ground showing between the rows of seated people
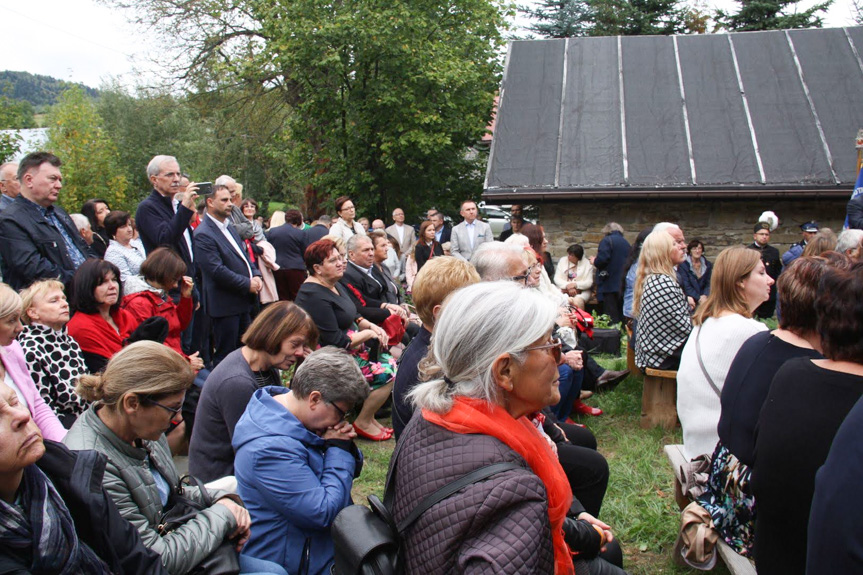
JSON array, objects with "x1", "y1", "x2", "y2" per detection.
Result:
[{"x1": 353, "y1": 358, "x2": 728, "y2": 575}]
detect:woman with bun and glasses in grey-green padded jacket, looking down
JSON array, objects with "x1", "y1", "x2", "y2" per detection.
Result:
[{"x1": 64, "y1": 341, "x2": 270, "y2": 575}]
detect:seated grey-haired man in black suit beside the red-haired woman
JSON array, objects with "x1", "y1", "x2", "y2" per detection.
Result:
[{"x1": 339, "y1": 234, "x2": 407, "y2": 325}]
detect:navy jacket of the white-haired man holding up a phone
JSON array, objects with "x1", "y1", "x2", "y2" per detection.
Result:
[{"x1": 135, "y1": 190, "x2": 197, "y2": 277}]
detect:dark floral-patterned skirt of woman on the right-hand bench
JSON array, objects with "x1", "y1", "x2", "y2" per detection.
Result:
[{"x1": 698, "y1": 441, "x2": 755, "y2": 557}]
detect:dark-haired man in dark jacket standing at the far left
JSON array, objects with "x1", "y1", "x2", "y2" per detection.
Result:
[{"x1": 0, "y1": 152, "x2": 95, "y2": 290}]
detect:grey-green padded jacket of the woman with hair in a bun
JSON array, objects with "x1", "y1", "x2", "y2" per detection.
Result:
[{"x1": 63, "y1": 403, "x2": 237, "y2": 575}]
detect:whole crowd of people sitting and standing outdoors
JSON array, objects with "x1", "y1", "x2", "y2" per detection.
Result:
[{"x1": 0, "y1": 152, "x2": 863, "y2": 575}]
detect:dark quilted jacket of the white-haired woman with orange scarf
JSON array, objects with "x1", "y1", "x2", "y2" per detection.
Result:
[{"x1": 393, "y1": 417, "x2": 554, "y2": 575}]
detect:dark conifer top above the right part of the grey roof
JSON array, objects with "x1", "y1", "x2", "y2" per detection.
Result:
[{"x1": 716, "y1": 0, "x2": 833, "y2": 32}]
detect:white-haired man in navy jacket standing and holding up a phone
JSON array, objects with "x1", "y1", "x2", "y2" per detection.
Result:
[{"x1": 135, "y1": 156, "x2": 198, "y2": 277}]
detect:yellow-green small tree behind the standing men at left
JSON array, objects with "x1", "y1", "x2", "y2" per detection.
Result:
[{"x1": 46, "y1": 86, "x2": 131, "y2": 212}]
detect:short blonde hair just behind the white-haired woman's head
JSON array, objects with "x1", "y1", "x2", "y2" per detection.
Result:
[{"x1": 411, "y1": 258, "x2": 480, "y2": 331}]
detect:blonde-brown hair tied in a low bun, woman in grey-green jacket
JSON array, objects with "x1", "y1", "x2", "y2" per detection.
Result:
[{"x1": 75, "y1": 341, "x2": 195, "y2": 409}]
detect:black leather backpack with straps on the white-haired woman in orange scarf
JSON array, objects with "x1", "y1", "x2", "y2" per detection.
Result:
[{"x1": 330, "y1": 418, "x2": 524, "y2": 575}]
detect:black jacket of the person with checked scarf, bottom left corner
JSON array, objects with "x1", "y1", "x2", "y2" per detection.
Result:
[{"x1": 0, "y1": 440, "x2": 168, "y2": 575}]
